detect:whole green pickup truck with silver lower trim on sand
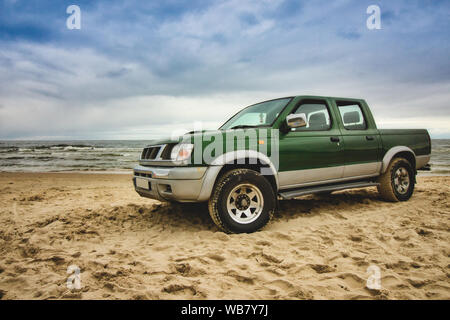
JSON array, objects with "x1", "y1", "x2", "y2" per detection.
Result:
[{"x1": 133, "y1": 96, "x2": 431, "y2": 233}]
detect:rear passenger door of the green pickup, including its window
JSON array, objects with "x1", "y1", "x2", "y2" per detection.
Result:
[{"x1": 335, "y1": 100, "x2": 381, "y2": 178}]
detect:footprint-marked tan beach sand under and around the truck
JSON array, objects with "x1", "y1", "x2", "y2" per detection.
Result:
[{"x1": 0, "y1": 173, "x2": 450, "y2": 299}]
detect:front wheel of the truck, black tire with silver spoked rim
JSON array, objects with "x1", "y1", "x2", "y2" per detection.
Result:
[{"x1": 208, "y1": 169, "x2": 276, "y2": 233}]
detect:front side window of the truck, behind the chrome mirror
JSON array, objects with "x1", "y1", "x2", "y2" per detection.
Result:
[{"x1": 292, "y1": 102, "x2": 331, "y2": 131}]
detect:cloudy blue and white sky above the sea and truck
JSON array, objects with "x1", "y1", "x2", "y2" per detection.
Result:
[{"x1": 0, "y1": 0, "x2": 450, "y2": 139}]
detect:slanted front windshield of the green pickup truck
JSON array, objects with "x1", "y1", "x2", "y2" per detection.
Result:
[{"x1": 220, "y1": 98, "x2": 291, "y2": 130}]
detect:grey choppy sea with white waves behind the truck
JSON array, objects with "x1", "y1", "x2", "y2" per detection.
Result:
[{"x1": 0, "y1": 139, "x2": 450, "y2": 175}]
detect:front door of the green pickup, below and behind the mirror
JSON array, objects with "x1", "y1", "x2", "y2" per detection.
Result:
[{"x1": 278, "y1": 99, "x2": 345, "y2": 189}]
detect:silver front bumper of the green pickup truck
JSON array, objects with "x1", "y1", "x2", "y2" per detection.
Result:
[{"x1": 133, "y1": 165, "x2": 222, "y2": 202}]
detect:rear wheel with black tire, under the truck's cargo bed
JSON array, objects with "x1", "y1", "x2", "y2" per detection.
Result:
[{"x1": 378, "y1": 158, "x2": 415, "y2": 202}]
